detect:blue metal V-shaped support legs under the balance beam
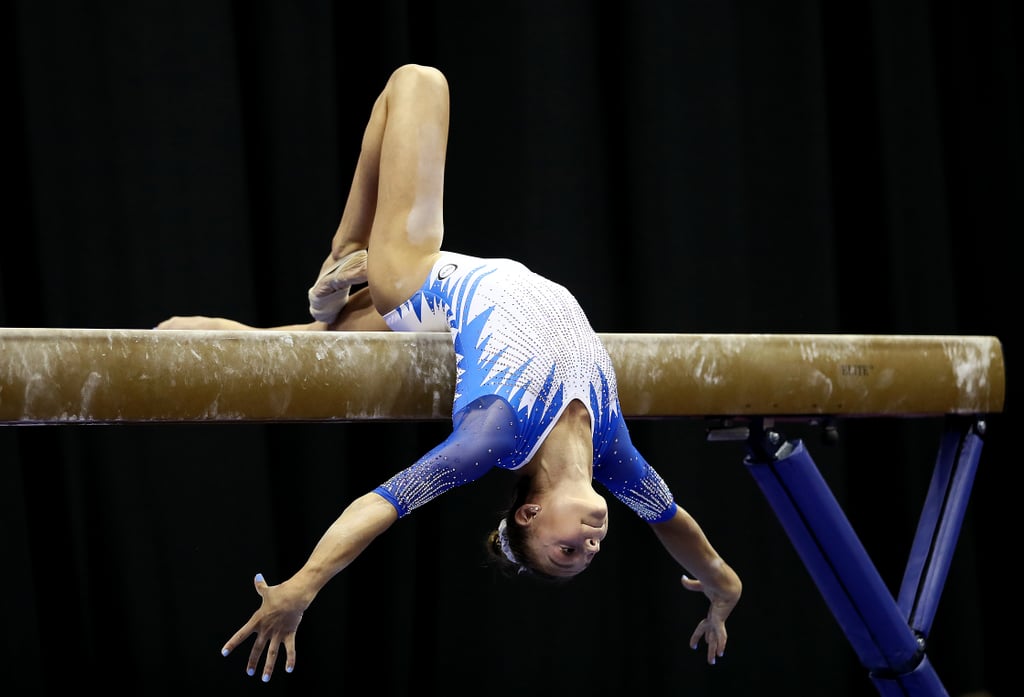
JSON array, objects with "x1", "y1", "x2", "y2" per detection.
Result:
[{"x1": 744, "y1": 423, "x2": 983, "y2": 697}]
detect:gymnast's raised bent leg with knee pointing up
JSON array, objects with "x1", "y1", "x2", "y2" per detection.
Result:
[{"x1": 310, "y1": 64, "x2": 449, "y2": 319}]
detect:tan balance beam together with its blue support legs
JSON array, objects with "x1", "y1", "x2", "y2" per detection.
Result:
[{"x1": 0, "y1": 329, "x2": 1006, "y2": 697}]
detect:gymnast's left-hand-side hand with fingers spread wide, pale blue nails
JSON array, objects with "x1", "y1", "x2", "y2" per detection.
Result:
[{"x1": 220, "y1": 573, "x2": 309, "y2": 683}]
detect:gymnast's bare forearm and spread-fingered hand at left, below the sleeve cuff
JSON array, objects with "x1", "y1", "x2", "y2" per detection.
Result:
[{"x1": 221, "y1": 492, "x2": 398, "y2": 683}]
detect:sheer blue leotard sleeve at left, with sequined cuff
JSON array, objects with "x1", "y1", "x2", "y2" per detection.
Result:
[{"x1": 374, "y1": 396, "x2": 518, "y2": 518}]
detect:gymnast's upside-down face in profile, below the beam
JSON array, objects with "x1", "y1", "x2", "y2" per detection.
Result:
[{"x1": 516, "y1": 491, "x2": 608, "y2": 576}]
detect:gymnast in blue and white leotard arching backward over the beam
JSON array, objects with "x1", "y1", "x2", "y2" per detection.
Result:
[{"x1": 158, "y1": 64, "x2": 741, "y2": 682}]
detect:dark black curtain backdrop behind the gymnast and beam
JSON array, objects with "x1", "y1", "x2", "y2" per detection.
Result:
[{"x1": 0, "y1": 0, "x2": 1024, "y2": 697}]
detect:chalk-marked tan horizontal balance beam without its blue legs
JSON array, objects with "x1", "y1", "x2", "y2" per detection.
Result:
[{"x1": 0, "y1": 329, "x2": 1006, "y2": 425}]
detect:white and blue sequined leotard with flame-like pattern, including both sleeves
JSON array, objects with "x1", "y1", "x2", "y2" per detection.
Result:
[{"x1": 375, "y1": 252, "x2": 676, "y2": 522}]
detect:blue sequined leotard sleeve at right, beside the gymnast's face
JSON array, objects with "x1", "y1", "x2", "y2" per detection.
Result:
[{"x1": 594, "y1": 418, "x2": 676, "y2": 523}]
